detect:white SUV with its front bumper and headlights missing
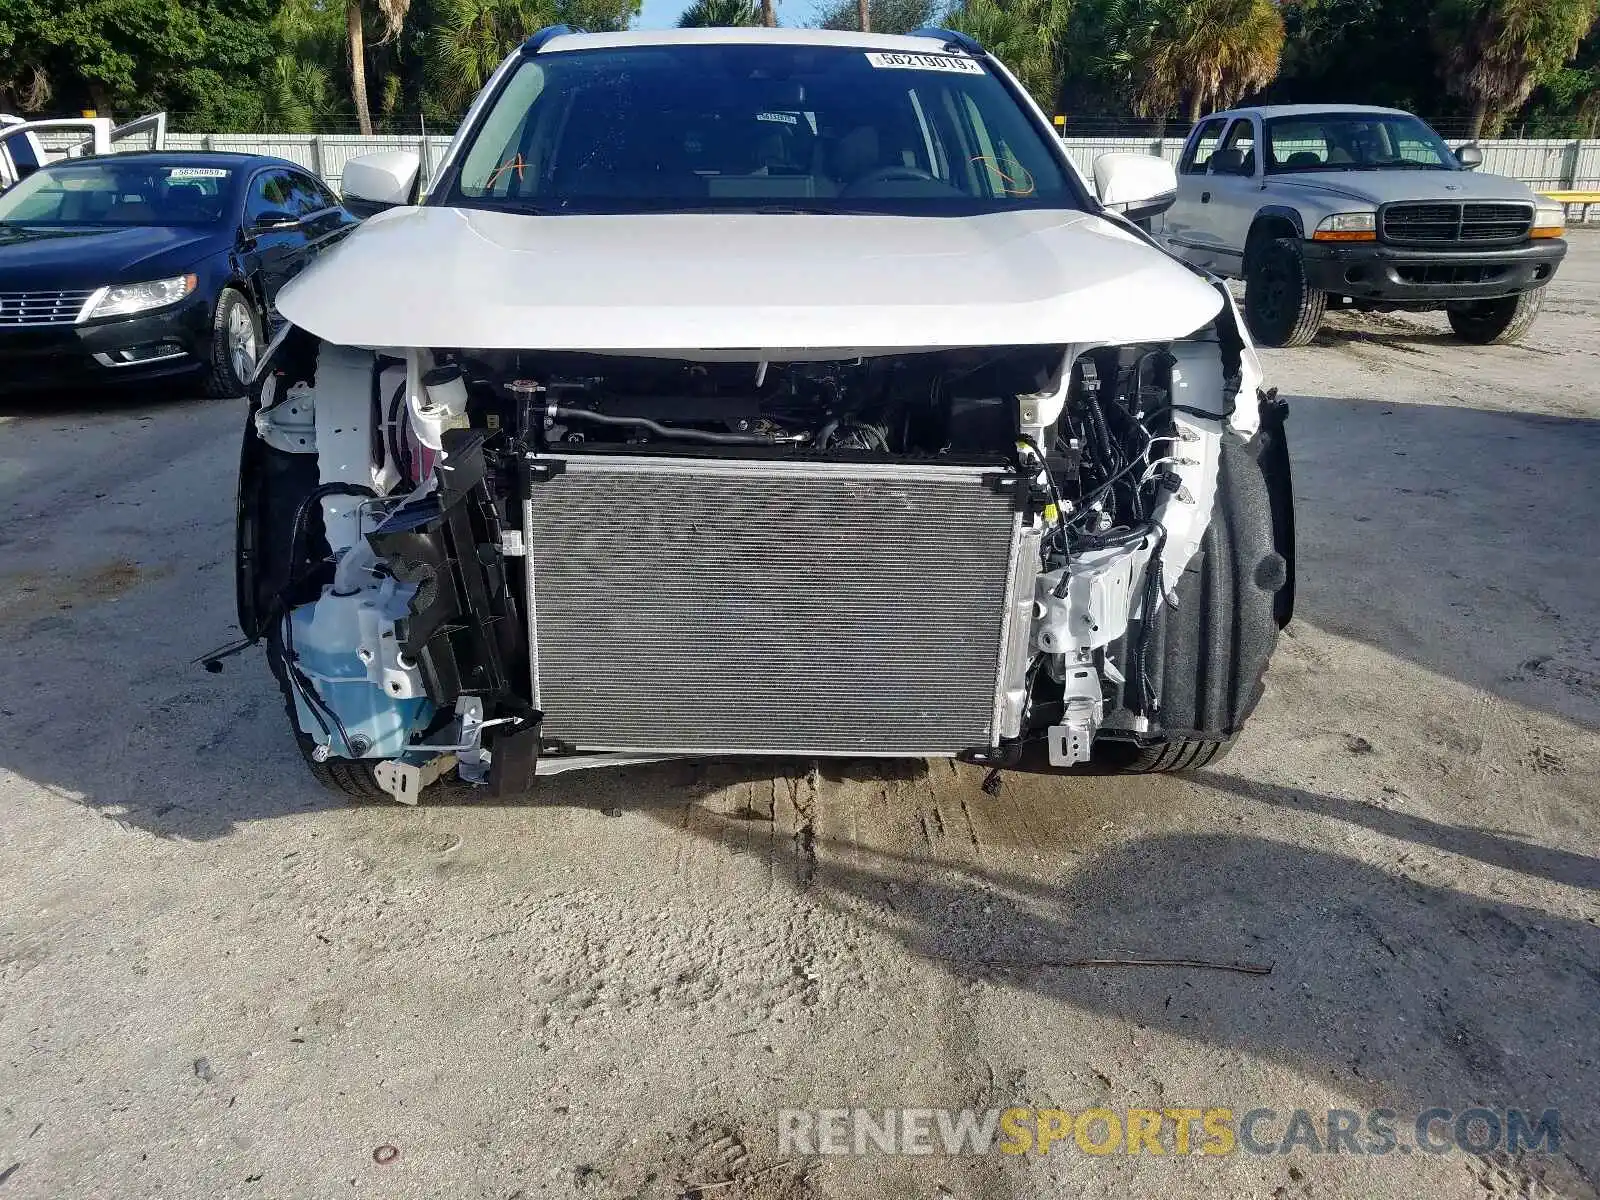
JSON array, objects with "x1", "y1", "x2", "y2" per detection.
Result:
[{"x1": 238, "y1": 29, "x2": 1293, "y2": 802}]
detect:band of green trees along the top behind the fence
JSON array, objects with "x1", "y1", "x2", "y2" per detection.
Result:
[{"x1": 0, "y1": 0, "x2": 1600, "y2": 136}]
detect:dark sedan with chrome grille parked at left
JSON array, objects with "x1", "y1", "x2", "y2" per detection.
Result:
[{"x1": 0, "y1": 152, "x2": 357, "y2": 397}]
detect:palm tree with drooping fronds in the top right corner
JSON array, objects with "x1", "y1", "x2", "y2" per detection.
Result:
[{"x1": 1434, "y1": 0, "x2": 1595, "y2": 139}]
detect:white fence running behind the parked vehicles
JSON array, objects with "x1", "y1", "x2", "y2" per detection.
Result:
[{"x1": 166, "y1": 133, "x2": 1600, "y2": 192}]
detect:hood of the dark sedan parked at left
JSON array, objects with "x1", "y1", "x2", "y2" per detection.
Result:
[{"x1": 0, "y1": 226, "x2": 227, "y2": 291}]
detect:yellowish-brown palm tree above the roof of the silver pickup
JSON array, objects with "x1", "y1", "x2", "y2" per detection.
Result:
[{"x1": 1117, "y1": 0, "x2": 1283, "y2": 123}]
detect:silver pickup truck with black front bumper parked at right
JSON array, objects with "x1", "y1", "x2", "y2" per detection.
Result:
[{"x1": 1152, "y1": 104, "x2": 1566, "y2": 346}]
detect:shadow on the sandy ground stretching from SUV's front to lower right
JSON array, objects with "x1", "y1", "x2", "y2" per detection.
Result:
[{"x1": 604, "y1": 763, "x2": 1600, "y2": 1195}]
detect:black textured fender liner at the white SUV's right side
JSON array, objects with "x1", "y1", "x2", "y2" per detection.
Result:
[{"x1": 1128, "y1": 395, "x2": 1294, "y2": 741}]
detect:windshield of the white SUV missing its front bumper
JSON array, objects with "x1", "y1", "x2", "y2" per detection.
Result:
[{"x1": 435, "y1": 45, "x2": 1083, "y2": 214}]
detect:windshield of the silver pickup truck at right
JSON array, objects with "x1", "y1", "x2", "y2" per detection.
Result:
[{"x1": 1266, "y1": 112, "x2": 1461, "y2": 174}]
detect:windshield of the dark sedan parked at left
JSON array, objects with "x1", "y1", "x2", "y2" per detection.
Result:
[{"x1": 0, "y1": 158, "x2": 234, "y2": 226}]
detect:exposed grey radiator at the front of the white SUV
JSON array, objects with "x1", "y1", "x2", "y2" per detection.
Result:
[{"x1": 523, "y1": 456, "x2": 1021, "y2": 755}]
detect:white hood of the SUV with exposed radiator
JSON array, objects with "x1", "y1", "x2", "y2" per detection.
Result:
[{"x1": 277, "y1": 206, "x2": 1222, "y2": 358}]
